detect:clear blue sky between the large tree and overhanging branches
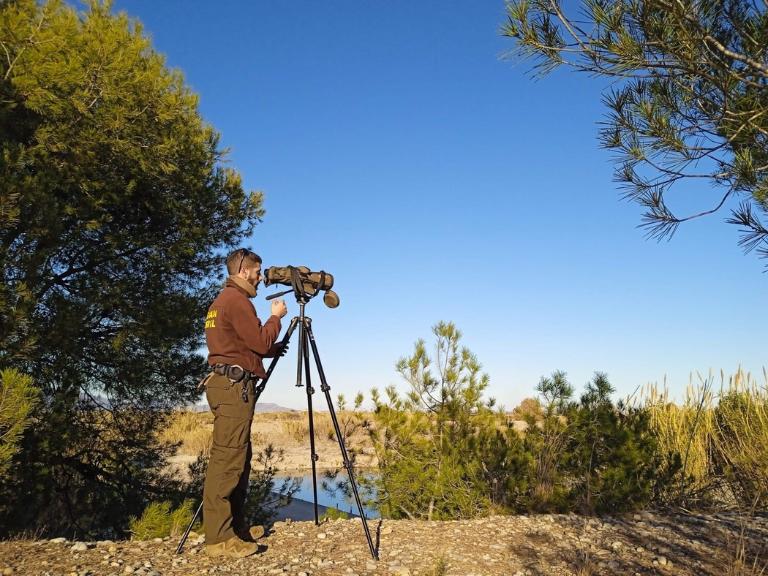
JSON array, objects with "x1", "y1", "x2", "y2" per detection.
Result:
[{"x1": 114, "y1": 0, "x2": 768, "y2": 408}]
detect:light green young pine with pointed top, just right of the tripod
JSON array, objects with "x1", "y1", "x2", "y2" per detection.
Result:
[{"x1": 372, "y1": 322, "x2": 493, "y2": 520}]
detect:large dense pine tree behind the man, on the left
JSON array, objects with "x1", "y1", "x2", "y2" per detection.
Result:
[{"x1": 0, "y1": 0, "x2": 262, "y2": 535}]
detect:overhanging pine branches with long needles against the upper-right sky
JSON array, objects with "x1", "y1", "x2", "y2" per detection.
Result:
[{"x1": 502, "y1": 0, "x2": 768, "y2": 266}]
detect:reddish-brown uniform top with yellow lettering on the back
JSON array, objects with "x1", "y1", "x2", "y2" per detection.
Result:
[{"x1": 205, "y1": 280, "x2": 280, "y2": 377}]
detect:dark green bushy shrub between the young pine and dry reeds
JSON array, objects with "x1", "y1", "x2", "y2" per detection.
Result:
[{"x1": 478, "y1": 371, "x2": 674, "y2": 514}]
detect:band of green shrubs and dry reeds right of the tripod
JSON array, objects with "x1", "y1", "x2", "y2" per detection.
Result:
[{"x1": 368, "y1": 324, "x2": 768, "y2": 519}]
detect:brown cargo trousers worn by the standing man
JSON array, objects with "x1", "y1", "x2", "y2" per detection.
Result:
[{"x1": 203, "y1": 374, "x2": 255, "y2": 544}]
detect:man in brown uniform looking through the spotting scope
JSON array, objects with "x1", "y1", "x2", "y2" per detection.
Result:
[{"x1": 203, "y1": 248, "x2": 287, "y2": 558}]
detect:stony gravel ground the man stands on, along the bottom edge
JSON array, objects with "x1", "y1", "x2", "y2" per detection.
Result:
[{"x1": 0, "y1": 512, "x2": 768, "y2": 576}]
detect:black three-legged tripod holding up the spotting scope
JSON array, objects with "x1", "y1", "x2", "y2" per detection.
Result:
[{"x1": 176, "y1": 278, "x2": 379, "y2": 560}]
